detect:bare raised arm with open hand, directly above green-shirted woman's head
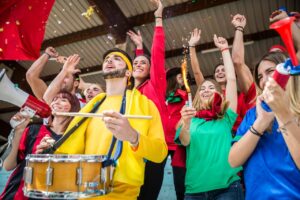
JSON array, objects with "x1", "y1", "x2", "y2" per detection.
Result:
[{"x1": 189, "y1": 28, "x2": 204, "y2": 87}]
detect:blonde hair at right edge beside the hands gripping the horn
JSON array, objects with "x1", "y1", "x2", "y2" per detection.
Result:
[{"x1": 286, "y1": 76, "x2": 300, "y2": 117}]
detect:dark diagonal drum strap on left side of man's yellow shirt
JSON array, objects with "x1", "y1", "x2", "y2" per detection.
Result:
[{"x1": 43, "y1": 96, "x2": 106, "y2": 154}]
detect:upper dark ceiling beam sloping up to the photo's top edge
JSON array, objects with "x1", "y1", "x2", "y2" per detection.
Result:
[{"x1": 42, "y1": 0, "x2": 237, "y2": 49}]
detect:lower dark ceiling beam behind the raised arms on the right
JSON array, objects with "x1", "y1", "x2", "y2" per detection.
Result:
[{"x1": 166, "y1": 30, "x2": 278, "y2": 58}]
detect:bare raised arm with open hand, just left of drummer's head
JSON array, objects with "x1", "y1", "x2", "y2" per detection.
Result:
[{"x1": 43, "y1": 54, "x2": 80, "y2": 105}]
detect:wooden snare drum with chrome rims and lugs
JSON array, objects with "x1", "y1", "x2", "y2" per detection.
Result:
[{"x1": 23, "y1": 154, "x2": 114, "y2": 199}]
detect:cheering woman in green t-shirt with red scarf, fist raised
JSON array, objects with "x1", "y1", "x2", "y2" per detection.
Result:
[{"x1": 175, "y1": 35, "x2": 244, "y2": 200}]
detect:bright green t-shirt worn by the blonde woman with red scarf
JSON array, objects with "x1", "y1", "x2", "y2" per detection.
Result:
[{"x1": 175, "y1": 109, "x2": 242, "y2": 194}]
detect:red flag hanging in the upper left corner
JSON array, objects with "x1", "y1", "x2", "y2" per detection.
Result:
[{"x1": 0, "y1": 0, "x2": 55, "y2": 60}]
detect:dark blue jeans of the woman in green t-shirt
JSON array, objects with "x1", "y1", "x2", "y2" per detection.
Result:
[{"x1": 184, "y1": 181, "x2": 244, "y2": 200}]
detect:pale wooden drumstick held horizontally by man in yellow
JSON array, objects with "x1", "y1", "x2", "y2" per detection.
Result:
[{"x1": 52, "y1": 112, "x2": 152, "y2": 119}]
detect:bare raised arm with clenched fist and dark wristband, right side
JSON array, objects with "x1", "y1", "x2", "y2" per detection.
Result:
[{"x1": 231, "y1": 14, "x2": 253, "y2": 94}]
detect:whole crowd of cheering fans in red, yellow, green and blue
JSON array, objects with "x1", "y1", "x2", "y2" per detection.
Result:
[{"x1": 0, "y1": 0, "x2": 300, "y2": 200}]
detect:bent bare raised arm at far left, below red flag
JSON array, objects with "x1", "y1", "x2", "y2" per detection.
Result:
[{"x1": 26, "y1": 47, "x2": 58, "y2": 100}]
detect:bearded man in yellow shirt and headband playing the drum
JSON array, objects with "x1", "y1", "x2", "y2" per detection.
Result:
[{"x1": 55, "y1": 49, "x2": 167, "y2": 200}]
